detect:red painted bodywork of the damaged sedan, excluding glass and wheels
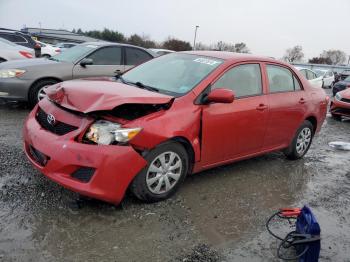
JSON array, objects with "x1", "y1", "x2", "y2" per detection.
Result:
[{"x1": 23, "y1": 52, "x2": 327, "y2": 203}]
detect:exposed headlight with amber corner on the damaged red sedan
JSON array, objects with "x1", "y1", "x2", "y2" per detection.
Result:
[{"x1": 85, "y1": 120, "x2": 141, "y2": 145}]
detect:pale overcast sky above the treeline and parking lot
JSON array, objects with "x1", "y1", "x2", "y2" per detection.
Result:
[{"x1": 0, "y1": 0, "x2": 350, "y2": 58}]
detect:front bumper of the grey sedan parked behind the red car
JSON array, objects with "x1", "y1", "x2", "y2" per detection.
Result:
[{"x1": 0, "y1": 77, "x2": 32, "y2": 101}]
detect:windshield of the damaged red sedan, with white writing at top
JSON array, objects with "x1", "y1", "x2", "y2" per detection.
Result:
[{"x1": 123, "y1": 53, "x2": 223, "y2": 95}]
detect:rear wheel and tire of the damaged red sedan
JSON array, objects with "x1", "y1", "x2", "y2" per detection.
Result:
[{"x1": 284, "y1": 120, "x2": 314, "y2": 160}]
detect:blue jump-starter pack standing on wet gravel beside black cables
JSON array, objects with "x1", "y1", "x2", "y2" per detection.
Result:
[{"x1": 296, "y1": 206, "x2": 321, "y2": 262}]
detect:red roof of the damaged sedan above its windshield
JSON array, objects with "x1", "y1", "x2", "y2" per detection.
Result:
[{"x1": 180, "y1": 51, "x2": 290, "y2": 66}]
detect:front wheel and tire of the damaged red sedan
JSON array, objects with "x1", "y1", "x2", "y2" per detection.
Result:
[{"x1": 130, "y1": 142, "x2": 189, "y2": 203}]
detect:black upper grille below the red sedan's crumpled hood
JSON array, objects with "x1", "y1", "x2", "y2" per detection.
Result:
[{"x1": 36, "y1": 108, "x2": 78, "y2": 136}]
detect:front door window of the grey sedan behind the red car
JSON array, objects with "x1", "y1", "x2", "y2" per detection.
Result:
[{"x1": 88, "y1": 47, "x2": 122, "y2": 65}]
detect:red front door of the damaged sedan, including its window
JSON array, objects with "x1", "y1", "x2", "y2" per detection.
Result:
[{"x1": 202, "y1": 63, "x2": 268, "y2": 166}]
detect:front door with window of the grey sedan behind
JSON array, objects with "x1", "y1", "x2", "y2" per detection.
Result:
[{"x1": 73, "y1": 46, "x2": 124, "y2": 78}]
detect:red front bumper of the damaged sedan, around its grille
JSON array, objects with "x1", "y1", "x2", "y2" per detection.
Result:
[{"x1": 23, "y1": 99, "x2": 147, "y2": 204}]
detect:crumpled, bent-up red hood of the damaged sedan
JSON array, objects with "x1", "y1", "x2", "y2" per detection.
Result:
[{"x1": 46, "y1": 78, "x2": 173, "y2": 113}]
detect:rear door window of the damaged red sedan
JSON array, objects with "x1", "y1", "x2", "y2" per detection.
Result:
[{"x1": 266, "y1": 65, "x2": 300, "y2": 93}]
